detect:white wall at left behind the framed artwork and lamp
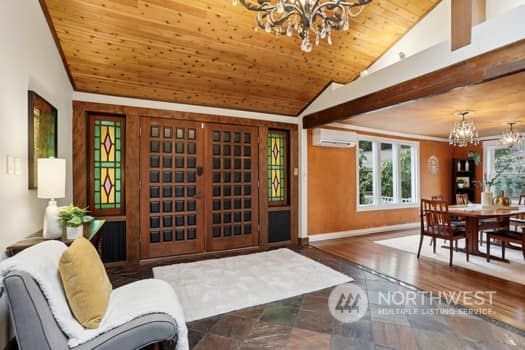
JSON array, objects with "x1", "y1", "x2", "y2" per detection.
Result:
[{"x1": 0, "y1": 0, "x2": 72, "y2": 348}]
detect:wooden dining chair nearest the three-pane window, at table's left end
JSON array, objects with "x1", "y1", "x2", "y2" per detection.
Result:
[{"x1": 417, "y1": 199, "x2": 469, "y2": 266}]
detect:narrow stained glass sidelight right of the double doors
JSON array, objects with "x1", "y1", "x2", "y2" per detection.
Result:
[{"x1": 267, "y1": 130, "x2": 288, "y2": 205}]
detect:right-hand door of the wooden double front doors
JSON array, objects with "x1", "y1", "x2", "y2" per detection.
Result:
[{"x1": 205, "y1": 124, "x2": 259, "y2": 251}]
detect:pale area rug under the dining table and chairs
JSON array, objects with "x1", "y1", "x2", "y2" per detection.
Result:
[{"x1": 375, "y1": 235, "x2": 525, "y2": 284}]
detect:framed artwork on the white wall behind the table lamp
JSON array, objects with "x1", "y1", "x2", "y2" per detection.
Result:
[{"x1": 27, "y1": 90, "x2": 57, "y2": 189}]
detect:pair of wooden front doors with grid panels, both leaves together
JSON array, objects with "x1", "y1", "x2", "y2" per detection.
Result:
[{"x1": 140, "y1": 118, "x2": 259, "y2": 259}]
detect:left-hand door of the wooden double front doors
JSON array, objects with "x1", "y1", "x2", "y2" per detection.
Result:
[{"x1": 140, "y1": 118, "x2": 205, "y2": 259}]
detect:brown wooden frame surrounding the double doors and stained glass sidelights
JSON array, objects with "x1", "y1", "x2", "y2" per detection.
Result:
[{"x1": 72, "y1": 101, "x2": 299, "y2": 264}]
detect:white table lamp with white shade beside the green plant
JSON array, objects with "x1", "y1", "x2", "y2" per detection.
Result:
[{"x1": 37, "y1": 158, "x2": 66, "y2": 238}]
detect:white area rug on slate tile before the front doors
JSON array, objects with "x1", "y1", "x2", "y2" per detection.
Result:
[{"x1": 153, "y1": 249, "x2": 352, "y2": 322}]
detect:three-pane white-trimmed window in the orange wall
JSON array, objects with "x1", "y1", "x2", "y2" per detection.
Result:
[{"x1": 356, "y1": 135, "x2": 419, "y2": 210}]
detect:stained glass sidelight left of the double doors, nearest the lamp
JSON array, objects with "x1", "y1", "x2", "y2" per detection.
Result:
[{"x1": 90, "y1": 116, "x2": 124, "y2": 215}]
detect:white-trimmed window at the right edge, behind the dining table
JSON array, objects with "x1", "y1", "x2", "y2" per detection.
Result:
[{"x1": 483, "y1": 141, "x2": 525, "y2": 200}]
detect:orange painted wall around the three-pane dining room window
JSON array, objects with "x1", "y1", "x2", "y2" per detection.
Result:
[{"x1": 308, "y1": 131, "x2": 454, "y2": 234}]
